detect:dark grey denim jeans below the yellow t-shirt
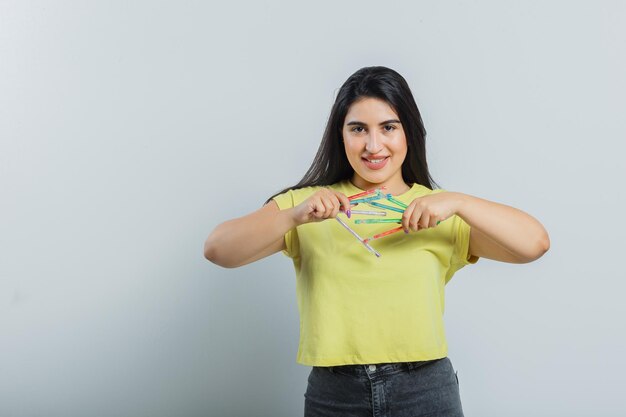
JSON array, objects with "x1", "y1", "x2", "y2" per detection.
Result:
[{"x1": 304, "y1": 357, "x2": 463, "y2": 417}]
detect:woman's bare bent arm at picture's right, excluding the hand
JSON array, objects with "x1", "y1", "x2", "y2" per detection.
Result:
[{"x1": 457, "y1": 193, "x2": 550, "y2": 260}]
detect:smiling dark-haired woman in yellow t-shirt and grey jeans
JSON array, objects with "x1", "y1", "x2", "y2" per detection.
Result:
[{"x1": 204, "y1": 67, "x2": 550, "y2": 417}]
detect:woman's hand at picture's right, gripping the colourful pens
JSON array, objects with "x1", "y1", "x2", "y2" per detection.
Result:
[{"x1": 402, "y1": 191, "x2": 460, "y2": 233}]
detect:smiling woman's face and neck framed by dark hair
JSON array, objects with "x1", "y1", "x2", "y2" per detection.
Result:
[{"x1": 342, "y1": 97, "x2": 407, "y2": 194}]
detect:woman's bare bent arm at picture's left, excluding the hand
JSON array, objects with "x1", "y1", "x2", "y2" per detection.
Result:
[{"x1": 204, "y1": 205, "x2": 296, "y2": 267}]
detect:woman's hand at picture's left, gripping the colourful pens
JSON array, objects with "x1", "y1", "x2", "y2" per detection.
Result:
[{"x1": 293, "y1": 188, "x2": 351, "y2": 225}]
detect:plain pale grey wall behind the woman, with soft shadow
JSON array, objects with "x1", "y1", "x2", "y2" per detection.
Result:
[{"x1": 0, "y1": 0, "x2": 626, "y2": 417}]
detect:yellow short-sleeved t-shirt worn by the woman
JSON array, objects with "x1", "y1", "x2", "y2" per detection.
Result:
[{"x1": 274, "y1": 180, "x2": 479, "y2": 366}]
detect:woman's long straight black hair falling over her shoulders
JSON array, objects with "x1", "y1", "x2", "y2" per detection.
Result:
[{"x1": 265, "y1": 66, "x2": 439, "y2": 204}]
